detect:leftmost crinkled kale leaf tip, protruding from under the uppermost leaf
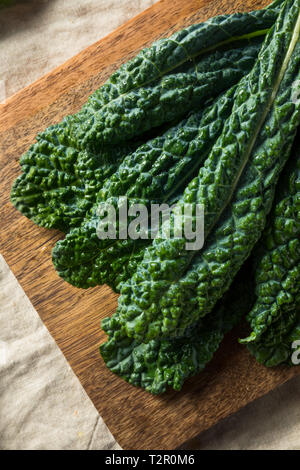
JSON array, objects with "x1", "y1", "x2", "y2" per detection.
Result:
[{"x1": 11, "y1": 119, "x2": 138, "y2": 232}]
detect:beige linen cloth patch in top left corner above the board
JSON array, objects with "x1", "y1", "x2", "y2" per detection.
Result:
[{"x1": 0, "y1": 0, "x2": 154, "y2": 102}]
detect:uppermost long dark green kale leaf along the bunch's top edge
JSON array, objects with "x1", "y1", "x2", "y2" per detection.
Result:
[{"x1": 73, "y1": 5, "x2": 278, "y2": 149}]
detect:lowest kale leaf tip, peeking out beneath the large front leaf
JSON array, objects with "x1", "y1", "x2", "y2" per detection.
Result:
[{"x1": 100, "y1": 263, "x2": 253, "y2": 394}]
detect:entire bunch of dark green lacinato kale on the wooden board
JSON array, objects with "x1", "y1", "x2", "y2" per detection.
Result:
[{"x1": 11, "y1": 0, "x2": 300, "y2": 394}]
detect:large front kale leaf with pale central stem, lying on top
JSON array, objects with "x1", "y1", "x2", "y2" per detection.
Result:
[{"x1": 112, "y1": 0, "x2": 300, "y2": 342}]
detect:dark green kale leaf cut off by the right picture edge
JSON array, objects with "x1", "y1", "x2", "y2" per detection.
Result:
[{"x1": 241, "y1": 135, "x2": 300, "y2": 366}]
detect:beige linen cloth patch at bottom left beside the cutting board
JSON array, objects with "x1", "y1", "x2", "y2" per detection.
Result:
[{"x1": 0, "y1": 255, "x2": 120, "y2": 450}]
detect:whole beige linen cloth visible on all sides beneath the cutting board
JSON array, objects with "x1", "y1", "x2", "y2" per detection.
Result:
[{"x1": 0, "y1": 0, "x2": 300, "y2": 449}]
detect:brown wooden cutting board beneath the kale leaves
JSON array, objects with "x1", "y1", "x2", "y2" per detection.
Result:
[{"x1": 0, "y1": 0, "x2": 300, "y2": 449}]
